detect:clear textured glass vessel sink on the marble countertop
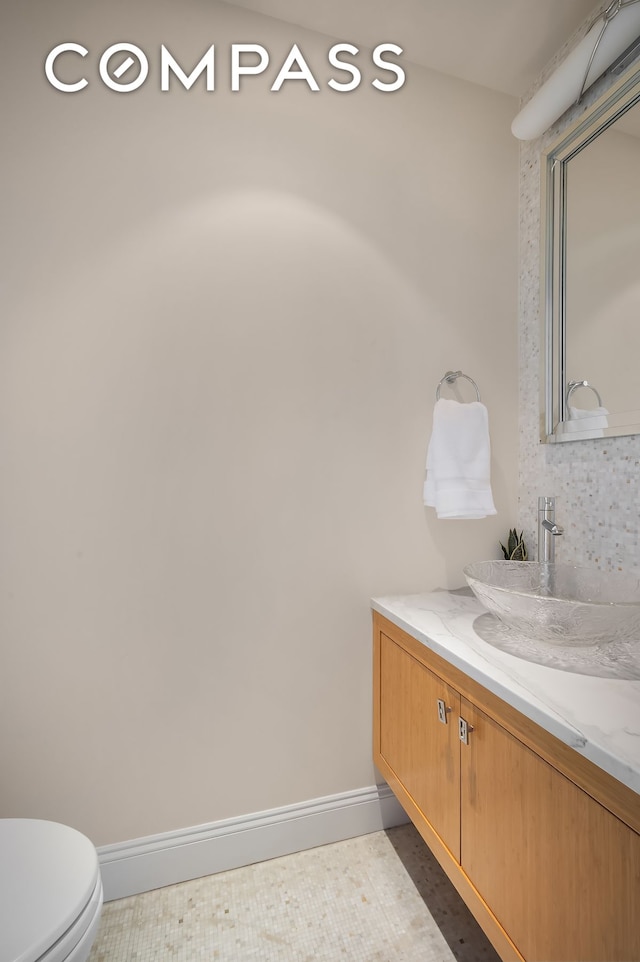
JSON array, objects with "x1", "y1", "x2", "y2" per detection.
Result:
[{"x1": 464, "y1": 561, "x2": 640, "y2": 646}]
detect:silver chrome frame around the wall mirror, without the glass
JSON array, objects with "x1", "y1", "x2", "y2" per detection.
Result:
[{"x1": 540, "y1": 60, "x2": 640, "y2": 443}]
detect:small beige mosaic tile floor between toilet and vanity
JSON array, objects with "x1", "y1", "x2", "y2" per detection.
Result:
[{"x1": 88, "y1": 825, "x2": 499, "y2": 962}]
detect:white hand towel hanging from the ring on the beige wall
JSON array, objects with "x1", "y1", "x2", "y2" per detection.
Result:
[{"x1": 424, "y1": 398, "x2": 496, "y2": 519}]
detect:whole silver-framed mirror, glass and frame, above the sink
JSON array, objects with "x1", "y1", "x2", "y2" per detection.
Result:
[{"x1": 541, "y1": 62, "x2": 640, "y2": 442}]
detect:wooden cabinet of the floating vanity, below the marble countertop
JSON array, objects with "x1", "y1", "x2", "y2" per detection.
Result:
[{"x1": 374, "y1": 613, "x2": 640, "y2": 962}]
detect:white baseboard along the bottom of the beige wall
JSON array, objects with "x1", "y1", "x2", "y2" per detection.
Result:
[{"x1": 98, "y1": 785, "x2": 408, "y2": 901}]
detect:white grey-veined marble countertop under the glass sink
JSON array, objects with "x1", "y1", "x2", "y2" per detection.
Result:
[{"x1": 372, "y1": 589, "x2": 640, "y2": 794}]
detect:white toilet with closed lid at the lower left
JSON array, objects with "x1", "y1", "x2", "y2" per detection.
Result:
[{"x1": 0, "y1": 818, "x2": 102, "y2": 962}]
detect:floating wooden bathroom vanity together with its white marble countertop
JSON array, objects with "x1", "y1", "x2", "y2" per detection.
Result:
[{"x1": 372, "y1": 590, "x2": 640, "y2": 962}]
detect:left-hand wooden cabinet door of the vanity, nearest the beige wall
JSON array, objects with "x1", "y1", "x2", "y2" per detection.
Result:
[{"x1": 379, "y1": 634, "x2": 460, "y2": 861}]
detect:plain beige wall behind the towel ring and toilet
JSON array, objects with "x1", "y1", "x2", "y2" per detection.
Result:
[{"x1": 0, "y1": 0, "x2": 517, "y2": 844}]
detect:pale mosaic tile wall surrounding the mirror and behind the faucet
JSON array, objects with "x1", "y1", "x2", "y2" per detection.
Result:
[{"x1": 518, "y1": 4, "x2": 640, "y2": 574}]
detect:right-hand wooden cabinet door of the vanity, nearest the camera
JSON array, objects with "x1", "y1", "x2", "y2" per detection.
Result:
[{"x1": 461, "y1": 699, "x2": 640, "y2": 962}]
